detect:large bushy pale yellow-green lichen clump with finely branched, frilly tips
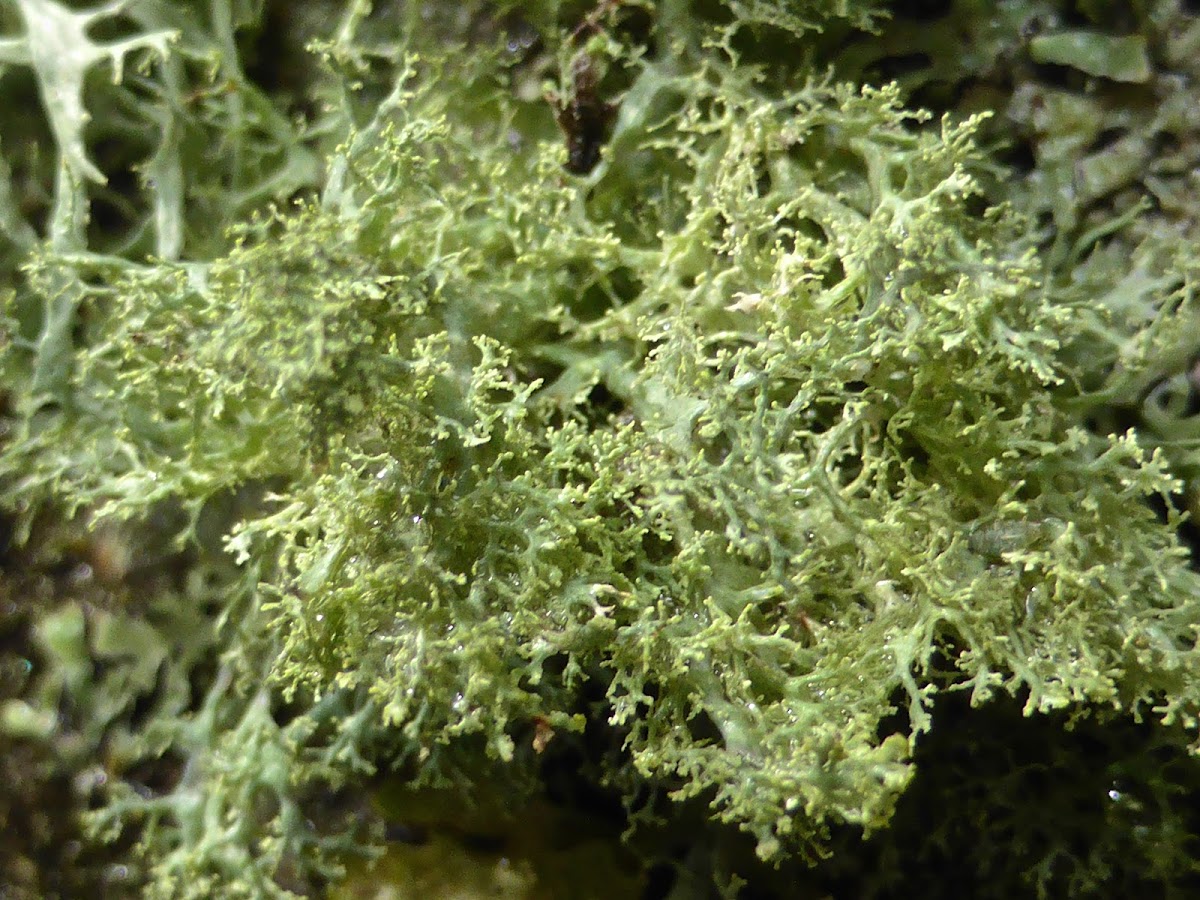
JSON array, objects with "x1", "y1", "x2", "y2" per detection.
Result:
[{"x1": 7, "y1": 0, "x2": 1200, "y2": 898}]
